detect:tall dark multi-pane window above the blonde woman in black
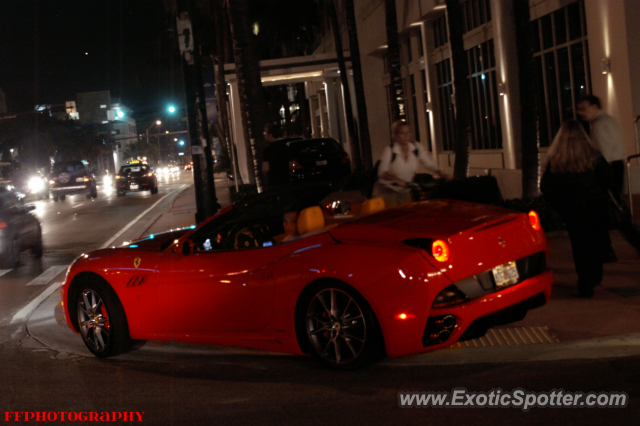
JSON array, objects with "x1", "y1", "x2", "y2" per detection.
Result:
[{"x1": 532, "y1": 0, "x2": 591, "y2": 147}]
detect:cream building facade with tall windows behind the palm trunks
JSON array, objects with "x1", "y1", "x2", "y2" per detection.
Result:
[{"x1": 308, "y1": 0, "x2": 640, "y2": 198}]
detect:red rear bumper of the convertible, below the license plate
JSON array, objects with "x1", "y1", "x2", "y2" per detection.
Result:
[{"x1": 384, "y1": 270, "x2": 553, "y2": 357}]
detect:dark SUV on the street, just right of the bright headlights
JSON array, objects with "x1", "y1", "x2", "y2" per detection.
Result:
[{"x1": 49, "y1": 161, "x2": 98, "y2": 201}]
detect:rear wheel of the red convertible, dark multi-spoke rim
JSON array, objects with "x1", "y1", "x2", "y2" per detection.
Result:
[{"x1": 300, "y1": 282, "x2": 383, "y2": 370}]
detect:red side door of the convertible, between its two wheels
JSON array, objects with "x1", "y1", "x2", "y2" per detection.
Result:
[{"x1": 156, "y1": 218, "x2": 291, "y2": 335}]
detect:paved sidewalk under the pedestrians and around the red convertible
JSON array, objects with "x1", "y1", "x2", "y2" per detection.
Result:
[{"x1": 27, "y1": 177, "x2": 640, "y2": 365}]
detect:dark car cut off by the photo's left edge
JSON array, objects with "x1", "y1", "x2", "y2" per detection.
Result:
[{"x1": 0, "y1": 186, "x2": 42, "y2": 268}]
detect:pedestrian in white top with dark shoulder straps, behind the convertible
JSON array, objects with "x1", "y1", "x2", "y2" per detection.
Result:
[{"x1": 373, "y1": 120, "x2": 443, "y2": 207}]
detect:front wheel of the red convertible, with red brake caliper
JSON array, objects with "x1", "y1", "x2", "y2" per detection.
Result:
[{"x1": 77, "y1": 278, "x2": 131, "y2": 358}]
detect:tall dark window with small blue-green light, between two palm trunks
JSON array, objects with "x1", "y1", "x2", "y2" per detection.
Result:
[{"x1": 467, "y1": 40, "x2": 502, "y2": 149}]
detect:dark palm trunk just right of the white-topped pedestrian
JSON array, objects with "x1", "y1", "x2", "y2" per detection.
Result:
[{"x1": 446, "y1": 0, "x2": 471, "y2": 179}]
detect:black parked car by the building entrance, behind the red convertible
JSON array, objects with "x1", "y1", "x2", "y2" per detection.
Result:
[{"x1": 262, "y1": 138, "x2": 351, "y2": 185}]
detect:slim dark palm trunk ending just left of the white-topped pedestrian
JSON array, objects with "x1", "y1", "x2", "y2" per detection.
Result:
[{"x1": 344, "y1": 0, "x2": 373, "y2": 171}]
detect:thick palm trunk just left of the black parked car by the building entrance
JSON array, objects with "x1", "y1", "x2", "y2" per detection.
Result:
[{"x1": 226, "y1": 0, "x2": 268, "y2": 192}]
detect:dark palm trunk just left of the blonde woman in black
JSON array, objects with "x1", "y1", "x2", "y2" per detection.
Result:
[{"x1": 512, "y1": 0, "x2": 540, "y2": 198}]
